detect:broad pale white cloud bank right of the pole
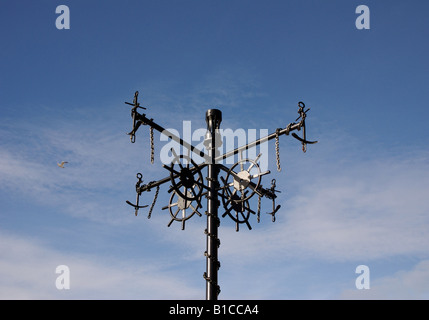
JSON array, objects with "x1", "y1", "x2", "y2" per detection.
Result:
[{"x1": 217, "y1": 151, "x2": 429, "y2": 261}]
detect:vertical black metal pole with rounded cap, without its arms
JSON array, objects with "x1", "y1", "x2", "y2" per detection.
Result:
[{"x1": 204, "y1": 109, "x2": 222, "y2": 300}]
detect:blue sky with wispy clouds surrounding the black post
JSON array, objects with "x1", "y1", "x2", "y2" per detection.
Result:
[{"x1": 0, "y1": 0, "x2": 429, "y2": 299}]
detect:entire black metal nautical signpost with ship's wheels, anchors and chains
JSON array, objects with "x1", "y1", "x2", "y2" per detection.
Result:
[{"x1": 125, "y1": 91, "x2": 317, "y2": 300}]
